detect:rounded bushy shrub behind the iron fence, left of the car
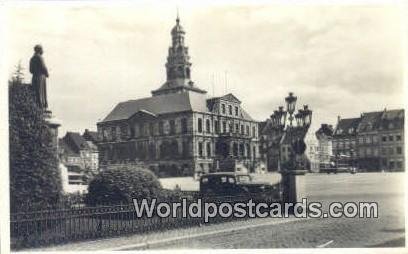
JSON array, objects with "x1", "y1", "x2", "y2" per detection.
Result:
[{"x1": 86, "y1": 166, "x2": 162, "y2": 205}]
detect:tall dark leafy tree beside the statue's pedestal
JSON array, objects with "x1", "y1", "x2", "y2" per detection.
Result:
[{"x1": 9, "y1": 69, "x2": 62, "y2": 211}]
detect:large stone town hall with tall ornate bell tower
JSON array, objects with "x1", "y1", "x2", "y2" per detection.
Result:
[{"x1": 97, "y1": 15, "x2": 265, "y2": 177}]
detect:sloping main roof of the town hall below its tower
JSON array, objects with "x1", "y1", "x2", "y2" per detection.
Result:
[{"x1": 102, "y1": 92, "x2": 208, "y2": 122}]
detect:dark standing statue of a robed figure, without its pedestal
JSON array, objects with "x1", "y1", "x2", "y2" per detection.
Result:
[{"x1": 30, "y1": 45, "x2": 48, "y2": 111}]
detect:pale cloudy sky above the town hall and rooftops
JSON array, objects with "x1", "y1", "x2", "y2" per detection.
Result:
[{"x1": 4, "y1": 2, "x2": 404, "y2": 136}]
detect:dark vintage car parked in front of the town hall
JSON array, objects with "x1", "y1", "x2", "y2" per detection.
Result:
[{"x1": 200, "y1": 172, "x2": 280, "y2": 199}]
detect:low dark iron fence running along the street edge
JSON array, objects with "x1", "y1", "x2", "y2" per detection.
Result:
[{"x1": 10, "y1": 196, "x2": 278, "y2": 249}]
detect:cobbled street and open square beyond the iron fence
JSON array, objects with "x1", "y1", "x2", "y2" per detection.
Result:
[{"x1": 33, "y1": 173, "x2": 405, "y2": 250}]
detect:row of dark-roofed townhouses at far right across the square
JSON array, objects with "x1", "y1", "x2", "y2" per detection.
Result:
[{"x1": 333, "y1": 109, "x2": 405, "y2": 171}]
